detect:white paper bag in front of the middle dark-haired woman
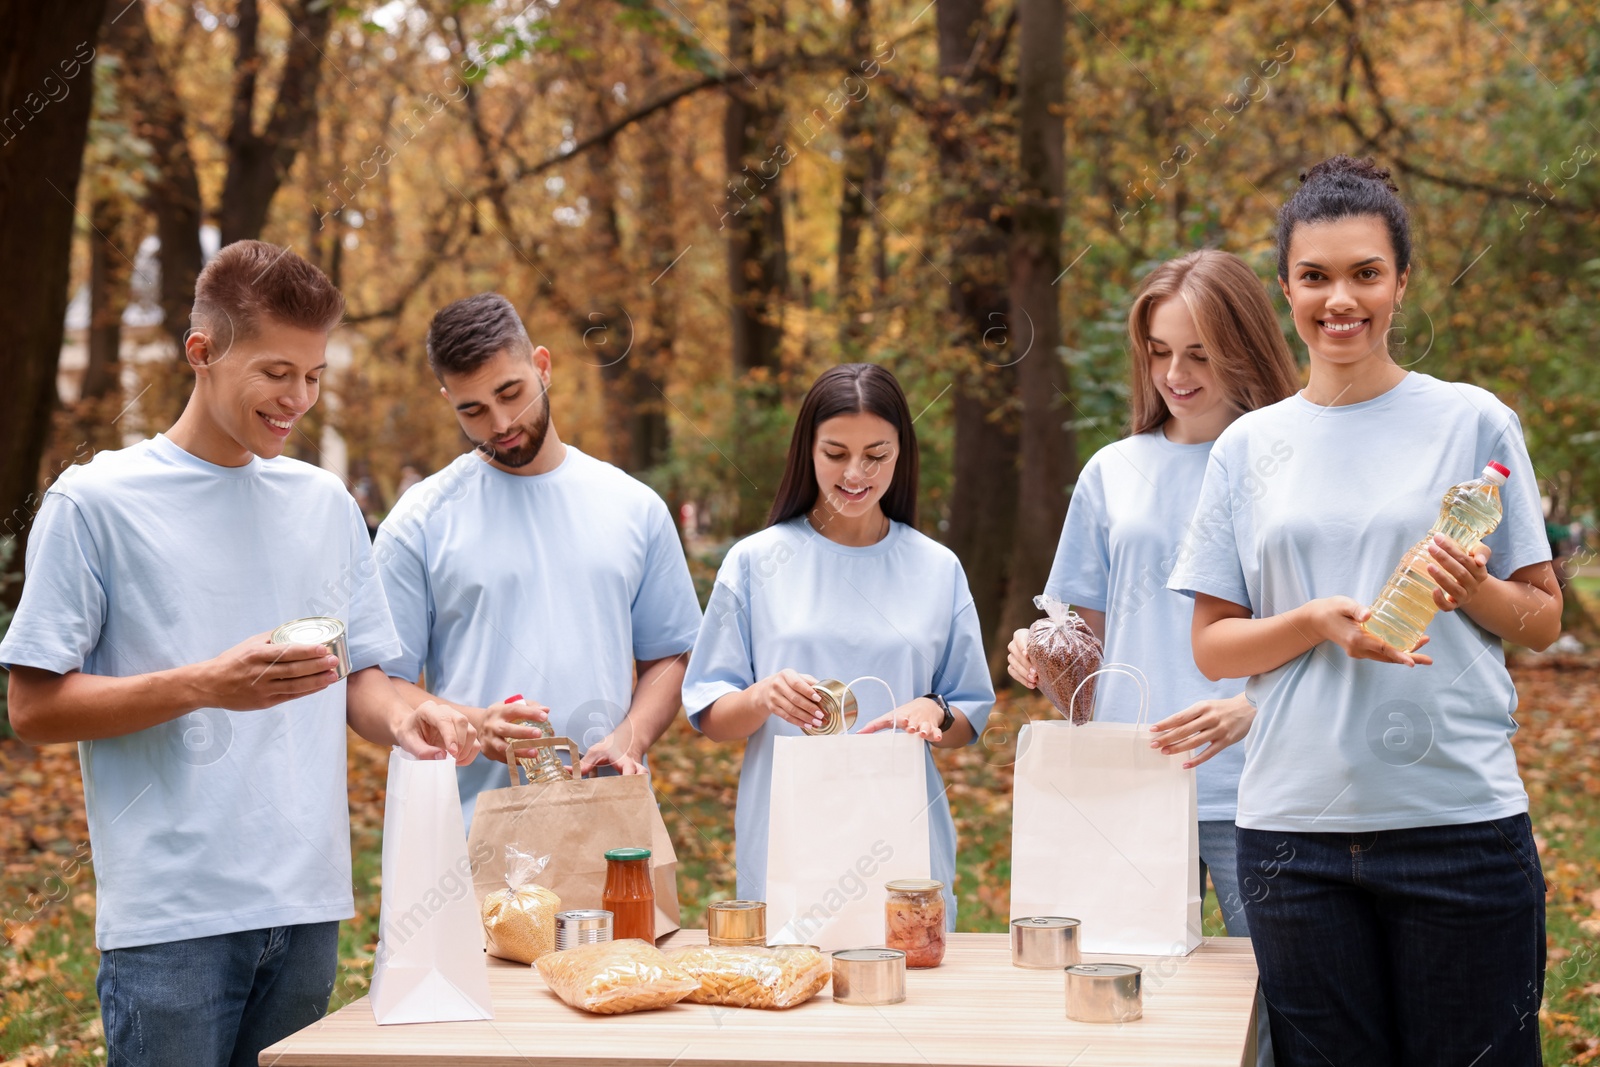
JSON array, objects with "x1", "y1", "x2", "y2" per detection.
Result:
[{"x1": 766, "y1": 731, "x2": 930, "y2": 952}]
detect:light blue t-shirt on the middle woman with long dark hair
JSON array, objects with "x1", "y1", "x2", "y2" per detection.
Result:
[{"x1": 683, "y1": 517, "x2": 995, "y2": 921}]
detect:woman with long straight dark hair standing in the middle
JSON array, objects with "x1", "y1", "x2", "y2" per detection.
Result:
[{"x1": 683, "y1": 363, "x2": 994, "y2": 929}]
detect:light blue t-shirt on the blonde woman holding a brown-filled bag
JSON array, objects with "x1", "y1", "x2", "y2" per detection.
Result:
[{"x1": 1045, "y1": 427, "x2": 1245, "y2": 821}]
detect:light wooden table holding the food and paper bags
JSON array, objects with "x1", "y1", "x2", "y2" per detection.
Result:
[{"x1": 261, "y1": 929, "x2": 1256, "y2": 1067}]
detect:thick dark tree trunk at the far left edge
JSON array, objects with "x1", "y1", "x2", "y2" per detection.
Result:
[{"x1": 0, "y1": 0, "x2": 106, "y2": 603}]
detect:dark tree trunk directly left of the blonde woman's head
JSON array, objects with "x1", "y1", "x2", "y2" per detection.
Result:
[{"x1": 990, "y1": 0, "x2": 1078, "y2": 677}]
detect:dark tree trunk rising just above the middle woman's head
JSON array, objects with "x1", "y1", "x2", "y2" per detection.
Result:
[{"x1": 718, "y1": 0, "x2": 794, "y2": 374}]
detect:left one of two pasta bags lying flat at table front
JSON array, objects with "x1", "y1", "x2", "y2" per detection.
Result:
[{"x1": 534, "y1": 937, "x2": 699, "y2": 1016}]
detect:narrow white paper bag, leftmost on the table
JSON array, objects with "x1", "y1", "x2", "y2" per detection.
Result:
[{"x1": 371, "y1": 749, "x2": 494, "y2": 1022}]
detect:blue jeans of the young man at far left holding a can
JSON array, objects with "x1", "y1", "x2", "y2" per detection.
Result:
[{"x1": 96, "y1": 923, "x2": 339, "y2": 1067}]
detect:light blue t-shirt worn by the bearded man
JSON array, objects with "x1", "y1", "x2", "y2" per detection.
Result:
[{"x1": 373, "y1": 445, "x2": 699, "y2": 822}]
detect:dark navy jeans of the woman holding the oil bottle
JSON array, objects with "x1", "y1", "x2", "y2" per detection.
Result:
[{"x1": 1238, "y1": 814, "x2": 1544, "y2": 1067}]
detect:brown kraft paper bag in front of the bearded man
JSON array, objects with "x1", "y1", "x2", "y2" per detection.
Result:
[{"x1": 467, "y1": 742, "x2": 678, "y2": 937}]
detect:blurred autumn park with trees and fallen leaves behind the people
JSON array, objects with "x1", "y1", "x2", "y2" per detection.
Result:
[{"x1": 0, "y1": 0, "x2": 1600, "y2": 1067}]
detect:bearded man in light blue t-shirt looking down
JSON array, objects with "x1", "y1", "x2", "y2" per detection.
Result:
[{"x1": 373, "y1": 293, "x2": 701, "y2": 821}]
